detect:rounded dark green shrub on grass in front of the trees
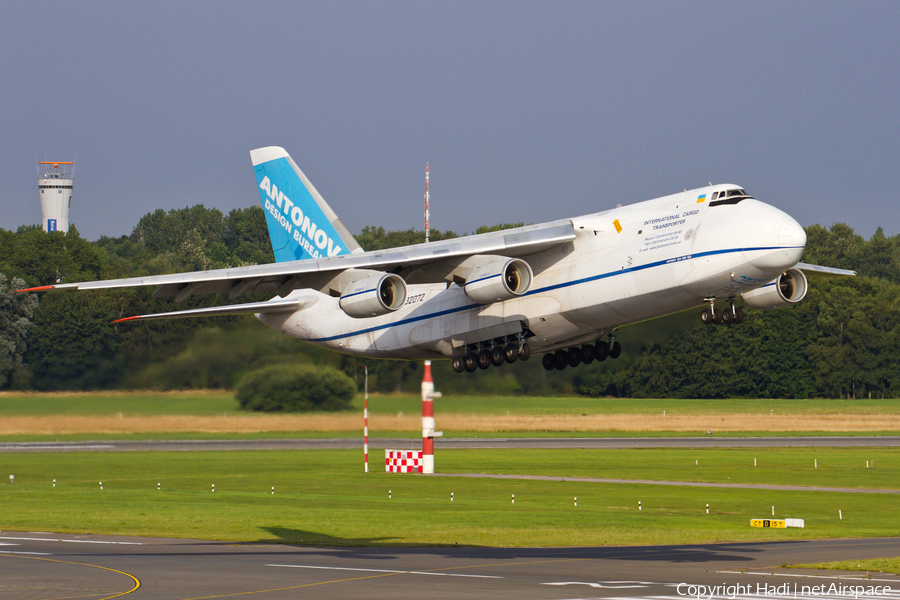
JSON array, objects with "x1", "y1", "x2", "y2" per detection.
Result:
[{"x1": 235, "y1": 365, "x2": 356, "y2": 412}]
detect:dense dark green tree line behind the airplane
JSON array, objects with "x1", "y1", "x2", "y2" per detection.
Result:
[{"x1": 0, "y1": 205, "x2": 900, "y2": 398}]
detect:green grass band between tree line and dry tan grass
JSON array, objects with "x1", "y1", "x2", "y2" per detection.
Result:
[{"x1": 0, "y1": 386, "x2": 900, "y2": 416}]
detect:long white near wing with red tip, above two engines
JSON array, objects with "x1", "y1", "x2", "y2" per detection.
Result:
[{"x1": 20, "y1": 219, "x2": 575, "y2": 300}]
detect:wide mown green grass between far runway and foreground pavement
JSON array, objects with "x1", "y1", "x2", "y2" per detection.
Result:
[{"x1": 0, "y1": 449, "x2": 900, "y2": 546}]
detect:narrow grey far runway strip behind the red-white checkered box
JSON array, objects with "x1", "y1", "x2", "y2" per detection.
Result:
[{"x1": 0, "y1": 436, "x2": 900, "y2": 452}]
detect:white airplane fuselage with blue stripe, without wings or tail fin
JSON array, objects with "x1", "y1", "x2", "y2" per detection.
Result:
[{"x1": 259, "y1": 185, "x2": 806, "y2": 359}]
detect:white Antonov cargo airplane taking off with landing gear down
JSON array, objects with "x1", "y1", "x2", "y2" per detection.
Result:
[{"x1": 22, "y1": 146, "x2": 856, "y2": 373}]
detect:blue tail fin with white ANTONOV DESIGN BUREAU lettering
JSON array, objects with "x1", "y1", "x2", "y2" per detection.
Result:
[{"x1": 250, "y1": 146, "x2": 362, "y2": 262}]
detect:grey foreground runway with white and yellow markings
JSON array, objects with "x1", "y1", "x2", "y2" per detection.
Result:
[{"x1": 0, "y1": 531, "x2": 900, "y2": 600}]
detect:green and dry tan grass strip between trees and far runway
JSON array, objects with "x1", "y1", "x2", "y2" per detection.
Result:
[{"x1": 0, "y1": 391, "x2": 900, "y2": 441}]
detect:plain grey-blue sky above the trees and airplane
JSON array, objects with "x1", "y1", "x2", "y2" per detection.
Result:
[{"x1": 0, "y1": 1, "x2": 900, "y2": 239}]
